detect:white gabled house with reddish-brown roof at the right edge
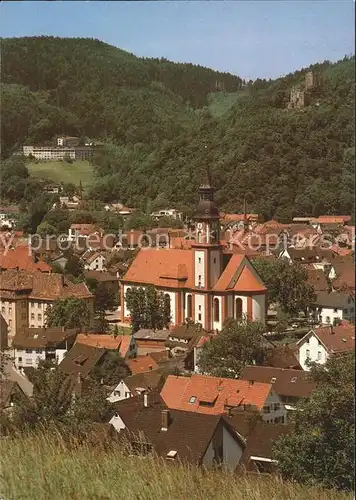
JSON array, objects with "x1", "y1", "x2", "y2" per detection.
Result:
[{"x1": 297, "y1": 321, "x2": 355, "y2": 371}]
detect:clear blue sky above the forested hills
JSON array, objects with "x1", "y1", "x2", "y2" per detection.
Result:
[{"x1": 0, "y1": 0, "x2": 355, "y2": 79}]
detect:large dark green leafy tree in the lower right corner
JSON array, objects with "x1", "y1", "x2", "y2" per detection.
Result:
[{"x1": 274, "y1": 353, "x2": 355, "y2": 490}]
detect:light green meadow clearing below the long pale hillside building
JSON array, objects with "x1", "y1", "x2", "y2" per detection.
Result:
[{"x1": 27, "y1": 160, "x2": 94, "y2": 189}]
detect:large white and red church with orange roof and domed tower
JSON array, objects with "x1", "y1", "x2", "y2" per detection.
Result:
[{"x1": 121, "y1": 181, "x2": 267, "y2": 331}]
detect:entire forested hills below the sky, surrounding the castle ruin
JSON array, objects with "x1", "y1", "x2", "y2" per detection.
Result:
[{"x1": 1, "y1": 37, "x2": 355, "y2": 219}]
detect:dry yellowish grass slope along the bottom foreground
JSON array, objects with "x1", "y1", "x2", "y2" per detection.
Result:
[{"x1": 0, "y1": 433, "x2": 353, "y2": 500}]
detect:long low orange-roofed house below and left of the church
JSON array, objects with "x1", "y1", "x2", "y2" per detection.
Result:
[{"x1": 76, "y1": 333, "x2": 136, "y2": 359}]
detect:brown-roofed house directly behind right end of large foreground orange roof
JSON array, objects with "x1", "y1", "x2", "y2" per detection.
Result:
[{"x1": 240, "y1": 365, "x2": 315, "y2": 411}]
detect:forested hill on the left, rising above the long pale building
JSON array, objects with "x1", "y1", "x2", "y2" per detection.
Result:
[{"x1": 1, "y1": 37, "x2": 242, "y2": 154}]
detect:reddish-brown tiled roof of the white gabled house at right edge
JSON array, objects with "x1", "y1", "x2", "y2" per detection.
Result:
[{"x1": 297, "y1": 321, "x2": 355, "y2": 354}]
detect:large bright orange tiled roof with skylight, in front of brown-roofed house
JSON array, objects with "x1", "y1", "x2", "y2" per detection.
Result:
[{"x1": 161, "y1": 374, "x2": 272, "y2": 415}]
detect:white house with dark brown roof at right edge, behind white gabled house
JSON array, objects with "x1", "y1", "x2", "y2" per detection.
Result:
[{"x1": 310, "y1": 292, "x2": 355, "y2": 325}]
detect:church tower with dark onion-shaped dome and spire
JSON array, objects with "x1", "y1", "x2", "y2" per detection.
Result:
[{"x1": 192, "y1": 174, "x2": 223, "y2": 290}]
